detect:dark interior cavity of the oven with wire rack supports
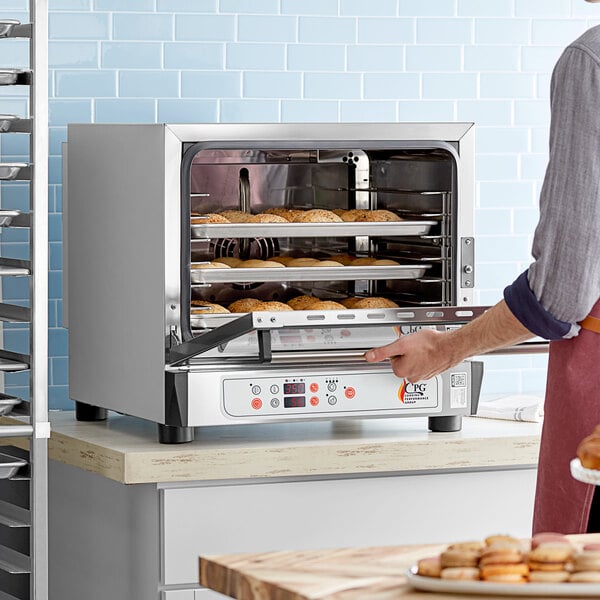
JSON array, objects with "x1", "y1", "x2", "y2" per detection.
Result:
[{"x1": 182, "y1": 144, "x2": 458, "y2": 350}]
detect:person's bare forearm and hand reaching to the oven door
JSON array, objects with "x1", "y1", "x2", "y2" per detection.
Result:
[{"x1": 365, "y1": 300, "x2": 534, "y2": 382}]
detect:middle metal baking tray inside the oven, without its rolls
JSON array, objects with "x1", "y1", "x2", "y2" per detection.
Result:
[{"x1": 190, "y1": 264, "x2": 431, "y2": 285}]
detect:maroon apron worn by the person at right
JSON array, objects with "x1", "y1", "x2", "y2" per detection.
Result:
[{"x1": 533, "y1": 300, "x2": 600, "y2": 534}]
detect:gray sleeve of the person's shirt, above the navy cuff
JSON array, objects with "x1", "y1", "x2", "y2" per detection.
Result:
[{"x1": 528, "y1": 43, "x2": 600, "y2": 323}]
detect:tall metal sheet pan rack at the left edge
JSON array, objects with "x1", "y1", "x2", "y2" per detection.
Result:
[{"x1": 0, "y1": 0, "x2": 50, "y2": 600}]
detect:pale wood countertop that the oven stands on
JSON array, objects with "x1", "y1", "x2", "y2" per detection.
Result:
[{"x1": 25, "y1": 411, "x2": 541, "y2": 484}]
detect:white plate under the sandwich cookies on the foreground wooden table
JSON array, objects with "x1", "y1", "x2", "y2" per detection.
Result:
[{"x1": 405, "y1": 567, "x2": 600, "y2": 598}]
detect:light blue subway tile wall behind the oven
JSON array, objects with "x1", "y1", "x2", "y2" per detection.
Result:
[{"x1": 0, "y1": 0, "x2": 600, "y2": 408}]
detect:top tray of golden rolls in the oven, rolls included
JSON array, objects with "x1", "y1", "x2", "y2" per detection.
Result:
[{"x1": 190, "y1": 208, "x2": 438, "y2": 239}]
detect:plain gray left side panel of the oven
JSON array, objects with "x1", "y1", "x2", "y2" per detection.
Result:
[{"x1": 65, "y1": 125, "x2": 172, "y2": 423}]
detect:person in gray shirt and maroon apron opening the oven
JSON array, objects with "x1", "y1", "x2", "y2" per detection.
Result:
[{"x1": 365, "y1": 0, "x2": 600, "y2": 533}]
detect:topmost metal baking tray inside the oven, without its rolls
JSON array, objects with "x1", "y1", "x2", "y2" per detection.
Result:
[{"x1": 190, "y1": 217, "x2": 438, "y2": 239}]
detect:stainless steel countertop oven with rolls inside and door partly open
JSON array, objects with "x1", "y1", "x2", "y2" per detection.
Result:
[{"x1": 63, "y1": 123, "x2": 482, "y2": 442}]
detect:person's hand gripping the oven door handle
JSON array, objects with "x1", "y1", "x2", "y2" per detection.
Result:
[{"x1": 365, "y1": 329, "x2": 460, "y2": 383}]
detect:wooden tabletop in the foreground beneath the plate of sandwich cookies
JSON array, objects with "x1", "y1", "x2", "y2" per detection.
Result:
[{"x1": 200, "y1": 532, "x2": 600, "y2": 600}]
